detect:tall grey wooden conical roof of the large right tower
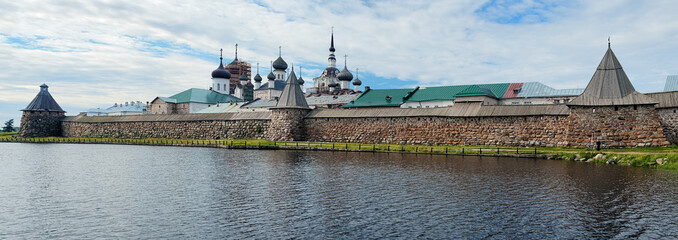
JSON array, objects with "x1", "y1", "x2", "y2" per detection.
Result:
[{"x1": 568, "y1": 46, "x2": 657, "y2": 106}]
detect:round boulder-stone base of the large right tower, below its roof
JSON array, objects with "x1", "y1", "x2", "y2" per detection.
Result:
[{"x1": 567, "y1": 105, "x2": 669, "y2": 147}]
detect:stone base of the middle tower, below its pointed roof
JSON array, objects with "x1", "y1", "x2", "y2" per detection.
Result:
[{"x1": 267, "y1": 108, "x2": 310, "y2": 141}]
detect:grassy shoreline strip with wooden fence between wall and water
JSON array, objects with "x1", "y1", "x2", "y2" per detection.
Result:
[{"x1": 0, "y1": 134, "x2": 678, "y2": 171}]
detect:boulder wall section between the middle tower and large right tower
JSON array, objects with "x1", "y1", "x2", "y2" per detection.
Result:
[{"x1": 305, "y1": 116, "x2": 568, "y2": 146}]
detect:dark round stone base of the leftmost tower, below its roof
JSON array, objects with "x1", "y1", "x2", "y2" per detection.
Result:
[{"x1": 17, "y1": 111, "x2": 64, "y2": 137}]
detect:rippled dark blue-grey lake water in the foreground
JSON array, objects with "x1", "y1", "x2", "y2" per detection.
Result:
[{"x1": 0, "y1": 143, "x2": 678, "y2": 239}]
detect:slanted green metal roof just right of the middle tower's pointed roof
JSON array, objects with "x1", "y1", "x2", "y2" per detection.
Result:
[{"x1": 343, "y1": 88, "x2": 418, "y2": 108}]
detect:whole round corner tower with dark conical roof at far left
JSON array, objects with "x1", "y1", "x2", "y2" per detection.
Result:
[{"x1": 17, "y1": 84, "x2": 66, "y2": 137}]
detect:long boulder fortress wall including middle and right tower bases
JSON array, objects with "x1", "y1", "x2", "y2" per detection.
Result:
[{"x1": 55, "y1": 105, "x2": 678, "y2": 147}]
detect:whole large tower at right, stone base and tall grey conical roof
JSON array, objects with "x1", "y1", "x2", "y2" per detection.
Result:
[{"x1": 566, "y1": 42, "x2": 669, "y2": 148}]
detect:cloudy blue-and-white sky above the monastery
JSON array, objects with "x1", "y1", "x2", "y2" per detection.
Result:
[{"x1": 0, "y1": 0, "x2": 678, "y2": 125}]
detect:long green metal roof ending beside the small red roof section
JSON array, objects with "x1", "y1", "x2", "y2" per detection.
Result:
[{"x1": 406, "y1": 83, "x2": 509, "y2": 102}]
